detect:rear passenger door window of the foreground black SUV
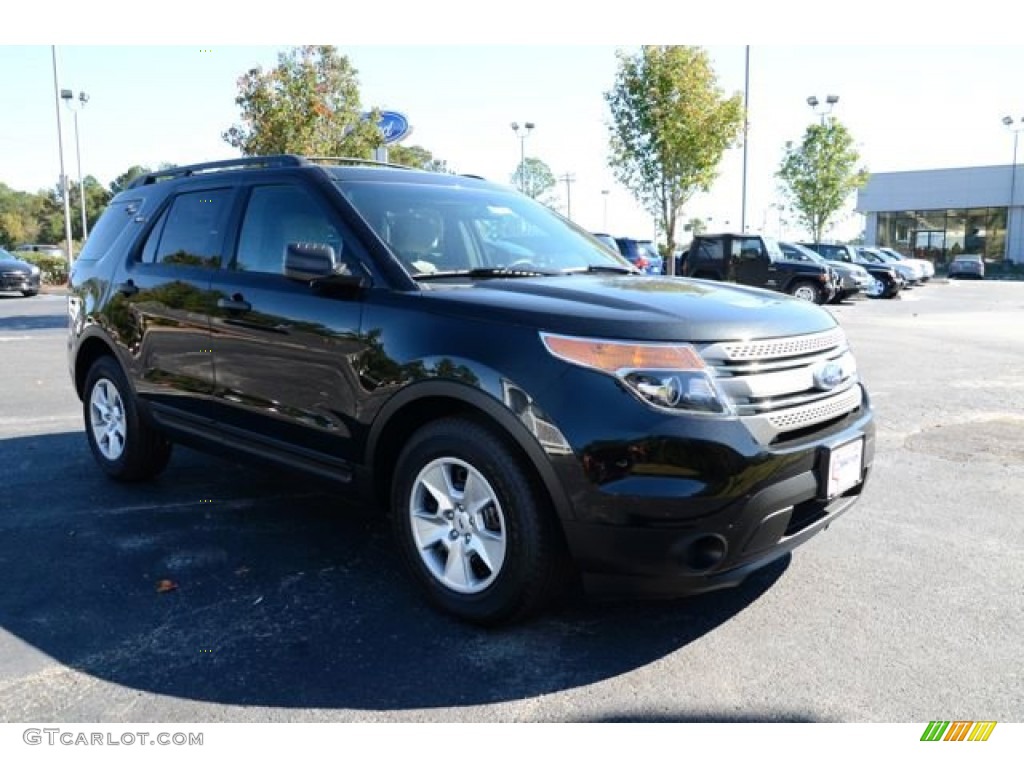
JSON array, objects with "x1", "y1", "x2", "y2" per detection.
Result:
[{"x1": 142, "y1": 189, "x2": 231, "y2": 267}]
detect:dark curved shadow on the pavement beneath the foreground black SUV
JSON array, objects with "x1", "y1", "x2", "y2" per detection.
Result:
[{"x1": 0, "y1": 433, "x2": 788, "y2": 717}]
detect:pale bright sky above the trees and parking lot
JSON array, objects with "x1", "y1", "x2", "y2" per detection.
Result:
[{"x1": 0, "y1": 6, "x2": 1024, "y2": 246}]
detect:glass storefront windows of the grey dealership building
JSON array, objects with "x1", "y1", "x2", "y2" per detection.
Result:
[{"x1": 878, "y1": 208, "x2": 1007, "y2": 264}]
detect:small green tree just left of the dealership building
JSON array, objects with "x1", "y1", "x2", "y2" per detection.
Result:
[{"x1": 775, "y1": 118, "x2": 867, "y2": 243}]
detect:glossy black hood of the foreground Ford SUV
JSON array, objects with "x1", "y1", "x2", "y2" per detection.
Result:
[{"x1": 413, "y1": 274, "x2": 836, "y2": 342}]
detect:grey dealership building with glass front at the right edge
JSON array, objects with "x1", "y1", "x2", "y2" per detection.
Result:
[{"x1": 857, "y1": 165, "x2": 1024, "y2": 263}]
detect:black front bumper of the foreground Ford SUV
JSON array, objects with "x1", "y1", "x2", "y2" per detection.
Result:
[{"x1": 563, "y1": 396, "x2": 874, "y2": 596}]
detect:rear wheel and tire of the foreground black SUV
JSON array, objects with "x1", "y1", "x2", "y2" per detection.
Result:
[{"x1": 82, "y1": 356, "x2": 171, "y2": 481}]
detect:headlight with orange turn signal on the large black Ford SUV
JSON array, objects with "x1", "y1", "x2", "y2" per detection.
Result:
[{"x1": 541, "y1": 333, "x2": 731, "y2": 414}]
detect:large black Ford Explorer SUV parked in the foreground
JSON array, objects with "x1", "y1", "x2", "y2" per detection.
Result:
[{"x1": 69, "y1": 156, "x2": 874, "y2": 624}]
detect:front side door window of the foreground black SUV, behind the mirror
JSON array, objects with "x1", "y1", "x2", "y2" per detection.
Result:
[{"x1": 234, "y1": 184, "x2": 342, "y2": 274}]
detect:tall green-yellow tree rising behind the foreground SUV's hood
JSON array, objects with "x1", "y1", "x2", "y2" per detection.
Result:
[{"x1": 604, "y1": 45, "x2": 743, "y2": 274}]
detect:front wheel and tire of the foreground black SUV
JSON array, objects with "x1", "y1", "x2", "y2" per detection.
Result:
[{"x1": 391, "y1": 418, "x2": 565, "y2": 626}]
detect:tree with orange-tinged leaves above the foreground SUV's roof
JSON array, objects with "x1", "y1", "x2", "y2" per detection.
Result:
[{"x1": 222, "y1": 45, "x2": 384, "y2": 158}]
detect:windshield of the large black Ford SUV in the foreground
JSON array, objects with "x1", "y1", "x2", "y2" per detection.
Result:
[{"x1": 335, "y1": 180, "x2": 633, "y2": 276}]
